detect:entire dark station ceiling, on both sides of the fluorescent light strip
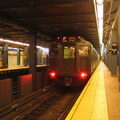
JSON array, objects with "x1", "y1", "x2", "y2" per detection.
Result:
[{"x1": 0, "y1": 0, "x2": 117, "y2": 52}]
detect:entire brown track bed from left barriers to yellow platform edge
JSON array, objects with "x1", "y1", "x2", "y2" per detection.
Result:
[{"x1": 0, "y1": 86, "x2": 80, "y2": 120}]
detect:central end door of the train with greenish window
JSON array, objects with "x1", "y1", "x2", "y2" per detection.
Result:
[{"x1": 60, "y1": 45, "x2": 76, "y2": 75}]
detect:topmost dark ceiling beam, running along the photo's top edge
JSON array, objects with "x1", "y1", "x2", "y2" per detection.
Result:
[{"x1": 0, "y1": 0, "x2": 89, "y2": 11}]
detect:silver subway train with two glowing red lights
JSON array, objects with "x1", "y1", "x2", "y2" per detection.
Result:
[{"x1": 48, "y1": 36, "x2": 100, "y2": 86}]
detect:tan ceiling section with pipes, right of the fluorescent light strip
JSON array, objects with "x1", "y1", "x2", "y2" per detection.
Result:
[{"x1": 103, "y1": 0, "x2": 118, "y2": 44}]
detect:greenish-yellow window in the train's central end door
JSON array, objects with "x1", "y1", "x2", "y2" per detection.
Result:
[{"x1": 64, "y1": 46, "x2": 75, "y2": 59}]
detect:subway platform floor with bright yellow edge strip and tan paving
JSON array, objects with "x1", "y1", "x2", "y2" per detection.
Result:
[{"x1": 65, "y1": 61, "x2": 120, "y2": 120}]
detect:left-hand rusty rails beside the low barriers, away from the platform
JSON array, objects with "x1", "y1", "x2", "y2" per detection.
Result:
[{"x1": 0, "y1": 85, "x2": 56, "y2": 120}]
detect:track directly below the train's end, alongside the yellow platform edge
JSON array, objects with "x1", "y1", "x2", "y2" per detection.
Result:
[{"x1": 22, "y1": 86, "x2": 81, "y2": 120}]
